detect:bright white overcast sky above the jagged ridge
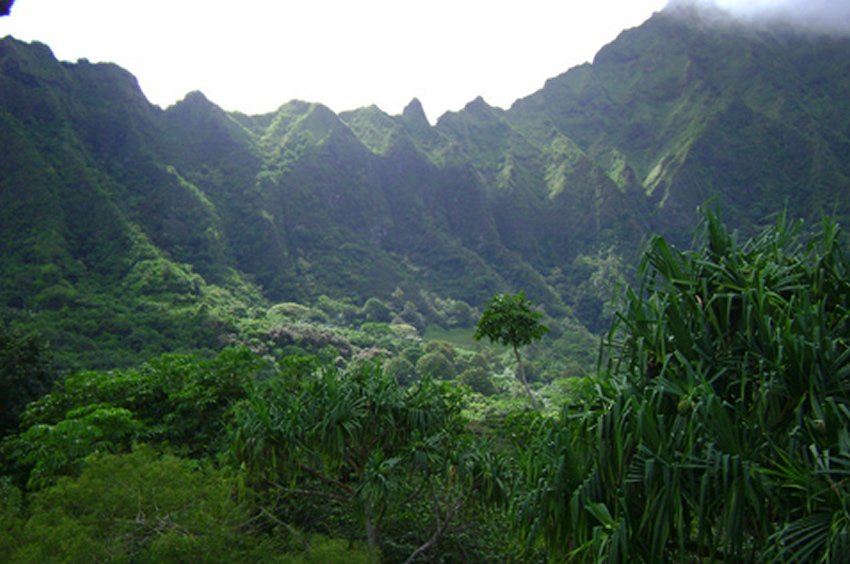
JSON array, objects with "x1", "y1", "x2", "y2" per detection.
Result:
[{"x1": 0, "y1": 0, "x2": 850, "y2": 121}]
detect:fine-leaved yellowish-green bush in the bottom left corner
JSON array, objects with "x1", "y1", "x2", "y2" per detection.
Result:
[{"x1": 0, "y1": 447, "x2": 371, "y2": 563}]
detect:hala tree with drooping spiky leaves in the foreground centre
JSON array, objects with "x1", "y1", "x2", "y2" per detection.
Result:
[{"x1": 227, "y1": 357, "x2": 506, "y2": 560}]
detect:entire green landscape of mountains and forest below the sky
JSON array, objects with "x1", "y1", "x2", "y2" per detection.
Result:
[{"x1": 0, "y1": 2, "x2": 850, "y2": 564}]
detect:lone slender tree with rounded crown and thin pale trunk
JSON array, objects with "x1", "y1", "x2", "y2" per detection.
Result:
[{"x1": 474, "y1": 292, "x2": 549, "y2": 409}]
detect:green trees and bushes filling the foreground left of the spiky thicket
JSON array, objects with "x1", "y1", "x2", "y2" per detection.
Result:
[{"x1": 0, "y1": 349, "x2": 511, "y2": 562}]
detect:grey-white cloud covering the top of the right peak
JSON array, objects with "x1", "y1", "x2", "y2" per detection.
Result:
[{"x1": 668, "y1": 0, "x2": 850, "y2": 35}]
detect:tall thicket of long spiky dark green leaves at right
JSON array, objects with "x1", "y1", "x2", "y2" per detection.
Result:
[{"x1": 520, "y1": 213, "x2": 850, "y2": 562}]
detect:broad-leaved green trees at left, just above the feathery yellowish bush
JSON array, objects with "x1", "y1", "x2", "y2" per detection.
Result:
[{"x1": 2, "y1": 349, "x2": 264, "y2": 487}]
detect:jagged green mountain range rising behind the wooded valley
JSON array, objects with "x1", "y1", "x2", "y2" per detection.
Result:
[{"x1": 0, "y1": 6, "x2": 850, "y2": 365}]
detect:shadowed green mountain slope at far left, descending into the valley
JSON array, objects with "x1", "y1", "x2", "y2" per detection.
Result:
[{"x1": 0, "y1": 40, "x2": 261, "y2": 366}]
